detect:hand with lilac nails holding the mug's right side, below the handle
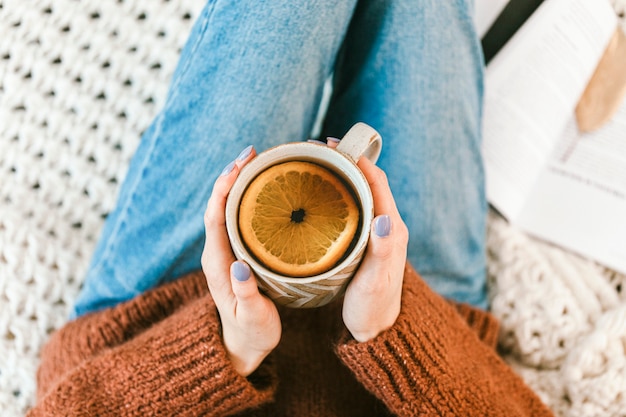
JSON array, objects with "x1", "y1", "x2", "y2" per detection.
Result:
[{"x1": 343, "y1": 158, "x2": 409, "y2": 342}]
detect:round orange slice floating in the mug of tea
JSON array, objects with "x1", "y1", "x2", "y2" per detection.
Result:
[{"x1": 239, "y1": 161, "x2": 359, "y2": 277}]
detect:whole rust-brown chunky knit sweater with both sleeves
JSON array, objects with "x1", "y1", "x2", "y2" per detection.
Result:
[{"x1": 28, "y1": 267, "x2": 551, "y2": 417}]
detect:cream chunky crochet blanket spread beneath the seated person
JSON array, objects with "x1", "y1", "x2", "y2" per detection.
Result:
[{"x1": 0, "y1": 0, "x2": 626, "y2": 417}]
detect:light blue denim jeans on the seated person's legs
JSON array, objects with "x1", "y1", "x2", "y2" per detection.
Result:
[{"x1": 73, "y1": 0, "x2": 487, "y2": 317}]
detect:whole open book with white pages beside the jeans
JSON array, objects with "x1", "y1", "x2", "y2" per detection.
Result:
[{"x1": 483, "y1": 0, "x2": 626, "y2": 273}]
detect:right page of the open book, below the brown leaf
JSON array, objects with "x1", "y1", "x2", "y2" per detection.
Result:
[{"x1": 519, "y1": 96, "x2": 626, "y2": 273}]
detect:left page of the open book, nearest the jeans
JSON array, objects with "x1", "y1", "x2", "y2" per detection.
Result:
[{"x1": 483, "y1": 0, "x2": 617, "y2": 221}]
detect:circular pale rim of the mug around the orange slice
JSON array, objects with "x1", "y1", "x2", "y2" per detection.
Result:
[{"x1": 226, "y1": 142, "x2": 374, "y2": 284}]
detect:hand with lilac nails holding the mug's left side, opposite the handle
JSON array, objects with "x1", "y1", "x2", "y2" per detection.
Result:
[{"x1": 202, "y1": 147, "x2": 282, "y2": 376}]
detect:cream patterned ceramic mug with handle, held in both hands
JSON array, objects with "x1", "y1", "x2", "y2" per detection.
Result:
[{"x1": 226, "y1": 123, "x2": 382, "y2": 308}]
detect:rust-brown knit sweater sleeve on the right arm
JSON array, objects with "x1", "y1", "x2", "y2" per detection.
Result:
[{"x1": 337, "y1": 266, "x2": 552, "y2": 416}]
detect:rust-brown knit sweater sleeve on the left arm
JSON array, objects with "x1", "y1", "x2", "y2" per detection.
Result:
[{"x1": 30, "y1": 272, "x2": 277, "y2": 416}]
